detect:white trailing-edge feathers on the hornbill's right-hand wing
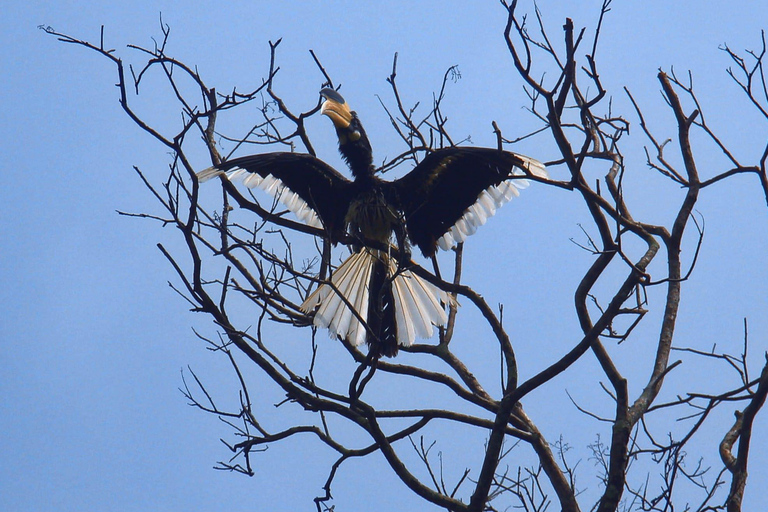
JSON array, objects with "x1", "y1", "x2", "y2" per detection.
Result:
[{"x1": 437, "y1": 155, "x2": 549, "y2": 251}]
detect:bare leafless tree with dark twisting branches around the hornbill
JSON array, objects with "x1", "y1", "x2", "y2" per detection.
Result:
[{"x1": 44, "y1": 0, "x2": 768, "y2": 512}]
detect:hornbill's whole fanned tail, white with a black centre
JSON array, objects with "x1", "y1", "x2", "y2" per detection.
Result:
[{"x1": 301, "y1": 248, "x2": 455, "y2": 357}]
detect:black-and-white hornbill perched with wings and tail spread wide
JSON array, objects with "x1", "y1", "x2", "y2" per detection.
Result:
[{"x1": 197, "y1": 88, "x2": 547, "y2": 357}]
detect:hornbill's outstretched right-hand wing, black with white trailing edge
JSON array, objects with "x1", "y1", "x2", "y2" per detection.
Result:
[{"x1": 392, "y1": 147, "x2": 547, "y2": 257}]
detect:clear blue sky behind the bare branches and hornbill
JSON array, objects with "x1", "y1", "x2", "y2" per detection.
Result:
[{"x1": 0, "y1": 0, "x2": 768, "y2": 512}]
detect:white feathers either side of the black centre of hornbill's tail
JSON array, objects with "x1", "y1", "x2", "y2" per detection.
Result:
[{"x1": 301, "y1": 248, "x2": 456, "y2": 347}]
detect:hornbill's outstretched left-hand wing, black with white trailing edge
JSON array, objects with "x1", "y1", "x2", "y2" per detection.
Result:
[{"x1": 197, "y1": 153, "x2": 351, "y2": 239}]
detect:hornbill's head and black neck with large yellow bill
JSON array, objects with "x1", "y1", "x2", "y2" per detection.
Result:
[{"x1": 320, "y1": 88, "x2": 373, "y2": 177}]
